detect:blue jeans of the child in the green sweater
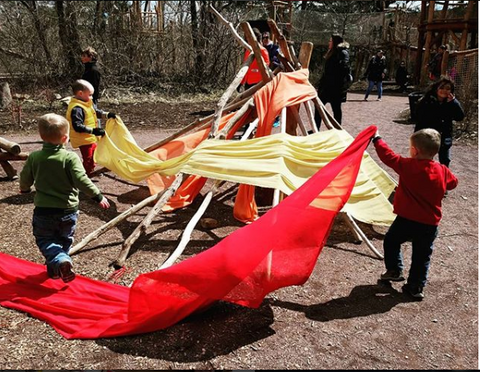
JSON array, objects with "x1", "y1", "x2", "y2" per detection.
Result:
[{"x1": 32, "y1": 212, "x2": 78, "y2": 273}]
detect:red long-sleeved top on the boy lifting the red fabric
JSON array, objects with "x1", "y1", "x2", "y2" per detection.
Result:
[{"x1": 375, "y1": 139, "x2": 458, "y2": 226}]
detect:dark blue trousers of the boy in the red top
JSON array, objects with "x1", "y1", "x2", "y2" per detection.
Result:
[{"x1": 383, "y1": 216, "x2": 438, "y2": 288}]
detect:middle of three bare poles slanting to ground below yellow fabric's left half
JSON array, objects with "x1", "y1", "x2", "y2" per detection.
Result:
[{"x1": 113, "y1": 173, "x2": 183, "y2": 266}]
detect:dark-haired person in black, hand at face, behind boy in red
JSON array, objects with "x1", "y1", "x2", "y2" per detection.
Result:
[{"x1": 415, "y1": 77, "x2": 465, "y2": 167}]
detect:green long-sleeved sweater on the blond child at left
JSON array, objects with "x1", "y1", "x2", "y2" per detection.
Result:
[{"x1": 20, "y1": 142, "x2": 103, "y2": 211}]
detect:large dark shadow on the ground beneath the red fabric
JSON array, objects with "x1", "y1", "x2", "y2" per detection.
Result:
[{"x1": 96, "y1": 302, "x2": 275, "y2": 363}]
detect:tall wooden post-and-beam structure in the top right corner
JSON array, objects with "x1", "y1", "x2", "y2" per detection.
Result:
[{"x1": 415, "y1": 0, "x2": 478, "y2": 84}]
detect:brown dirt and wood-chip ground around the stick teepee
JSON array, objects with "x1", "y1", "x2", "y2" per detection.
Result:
[{"x1": 0, "y1": 92, "x2": 478, "y2": 370}]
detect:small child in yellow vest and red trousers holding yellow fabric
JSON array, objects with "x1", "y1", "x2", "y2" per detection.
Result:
[{"x1": 66, "y1": 79, "x2": 116, "y2": 177}]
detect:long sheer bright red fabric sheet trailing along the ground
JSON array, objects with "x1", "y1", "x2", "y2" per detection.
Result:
[{"x1": 0, "y1": 126, "x2": 376, "y2": 339}]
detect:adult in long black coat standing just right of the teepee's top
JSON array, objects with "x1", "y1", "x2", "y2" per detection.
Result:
[{"x1": 315, "y1": 34, "x2": 352, "y2": 128}]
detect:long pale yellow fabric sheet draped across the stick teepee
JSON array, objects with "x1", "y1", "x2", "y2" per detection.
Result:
[{"x1": 95, "y1": 116, "x2": 395, "y2": 225}]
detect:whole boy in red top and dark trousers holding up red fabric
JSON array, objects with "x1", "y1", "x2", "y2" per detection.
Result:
[{"x1": 372, "y1": 128, "x2": 458, "y2": 301}]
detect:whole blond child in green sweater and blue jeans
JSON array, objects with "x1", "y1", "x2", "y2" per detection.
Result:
[{"x1": 20, "y1": 114, "x2": 110, "y2": 283}]
